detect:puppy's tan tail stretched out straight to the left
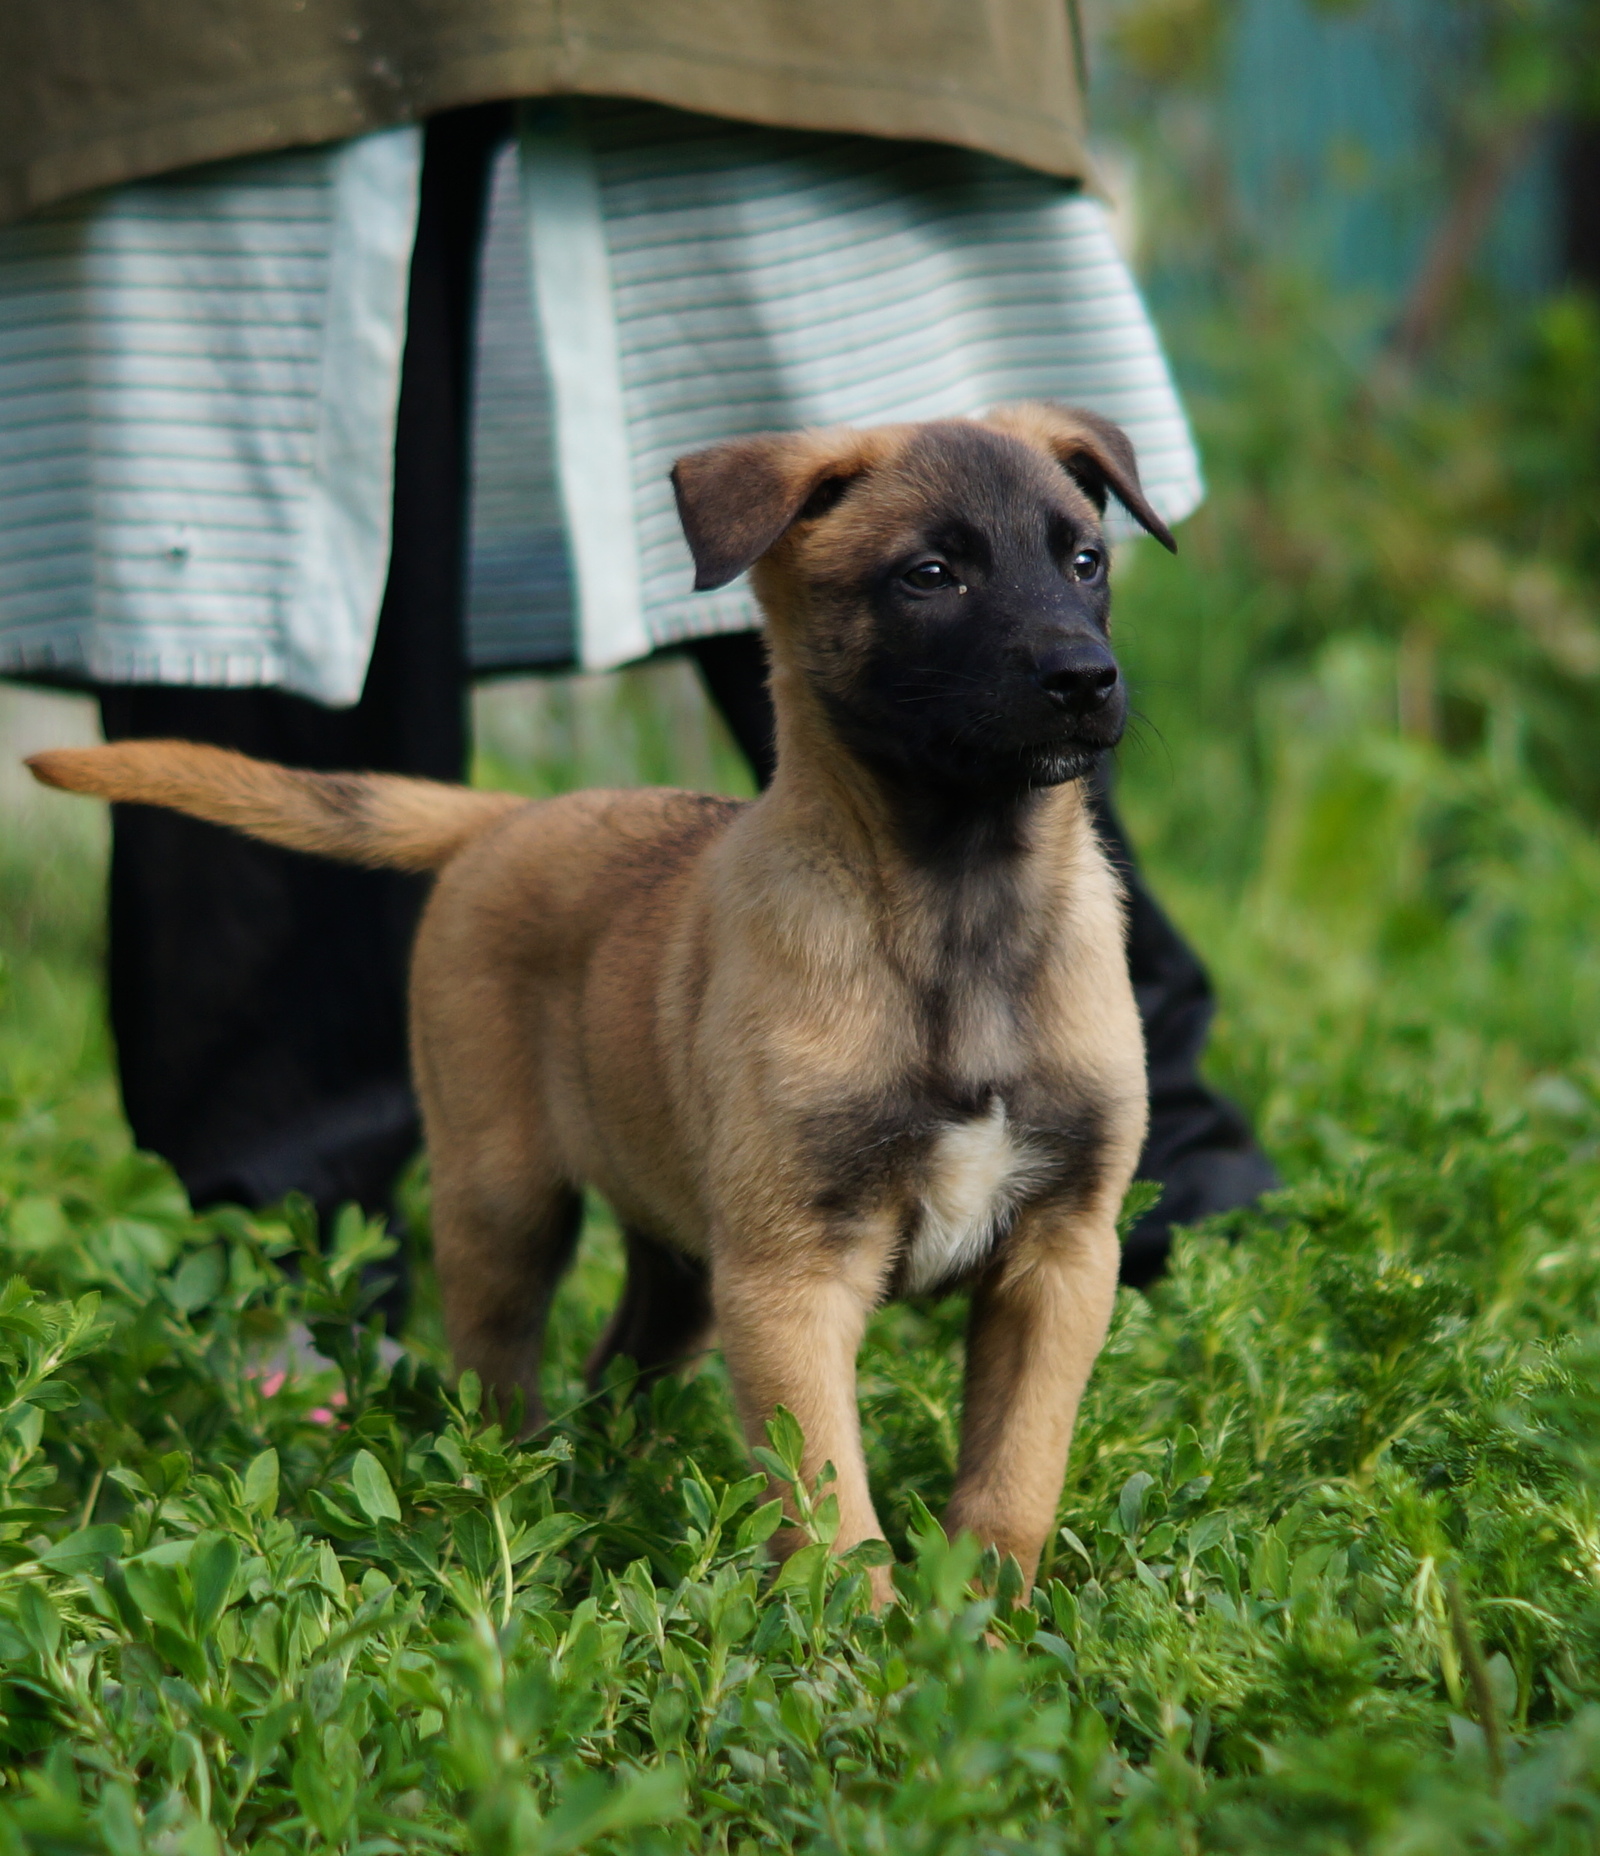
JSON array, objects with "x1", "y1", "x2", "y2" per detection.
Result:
[{"x1": 28, "y1": 741, "x2": 527, "y2": 870}]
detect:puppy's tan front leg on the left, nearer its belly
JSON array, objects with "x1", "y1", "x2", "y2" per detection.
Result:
[{"x1": 711, "y1": 1245, "x2": 891, "y2": 1604}]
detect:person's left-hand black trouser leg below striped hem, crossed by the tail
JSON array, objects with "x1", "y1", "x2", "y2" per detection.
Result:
[{"x1": 100, "y1": 689, "x2": 436, "y2": 1212}]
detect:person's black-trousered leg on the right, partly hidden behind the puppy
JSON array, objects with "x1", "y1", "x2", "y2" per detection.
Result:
[{"x1": 685, "y1": 631, "x2": 1277, "y2": 1288}]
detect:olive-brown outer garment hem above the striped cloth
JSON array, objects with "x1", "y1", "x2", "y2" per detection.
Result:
[{"x1": 0, "y1": 0, "x2": 1086, "y2": 219}]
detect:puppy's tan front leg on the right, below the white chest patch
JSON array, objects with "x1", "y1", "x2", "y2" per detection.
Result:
[{"x1": 945, "y1": 1208, "x2": 1117, "y2": 1583}]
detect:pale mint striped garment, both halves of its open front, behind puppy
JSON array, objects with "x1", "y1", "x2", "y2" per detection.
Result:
[{"x1": 0, "y1": 102, "x2": 1201, "y2": 703}]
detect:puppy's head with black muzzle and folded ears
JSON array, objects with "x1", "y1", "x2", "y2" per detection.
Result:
[{"x1": 672, "y1": 405, "x2": 1175, "y2": 791}]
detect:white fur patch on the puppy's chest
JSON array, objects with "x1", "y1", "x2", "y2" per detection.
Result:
[{"x1": 902, "y1": 1095, "x2": 1043, "y2": 1295}]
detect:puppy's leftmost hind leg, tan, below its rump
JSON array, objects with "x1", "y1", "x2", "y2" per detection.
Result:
[{"x1": 432, "y1": 1154, "x2": 583, "y2": 1431}]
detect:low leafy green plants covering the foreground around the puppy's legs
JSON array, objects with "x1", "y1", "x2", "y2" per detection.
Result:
[{"x1": 0, "y1": 1039, "x2": 1600, "y2": 1856}]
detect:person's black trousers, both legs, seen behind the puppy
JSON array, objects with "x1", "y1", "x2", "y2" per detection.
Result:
[{"x1": 100, "y1": 106, "x2": 1271, "y2": 1282}]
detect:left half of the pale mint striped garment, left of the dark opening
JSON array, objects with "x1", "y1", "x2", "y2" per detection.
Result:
[{"x1": 0, "y1": 130, "x2": 421, "y2": 702}]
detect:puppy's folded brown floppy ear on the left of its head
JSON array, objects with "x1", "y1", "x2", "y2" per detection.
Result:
[{"x1": 672, "y1": 427, "x2": 883, "y2": 592}]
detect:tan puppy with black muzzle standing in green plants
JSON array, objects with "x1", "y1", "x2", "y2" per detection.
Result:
[{"x1": 30, "y1": 405, "x2": 1171, "y2": 1592}]
